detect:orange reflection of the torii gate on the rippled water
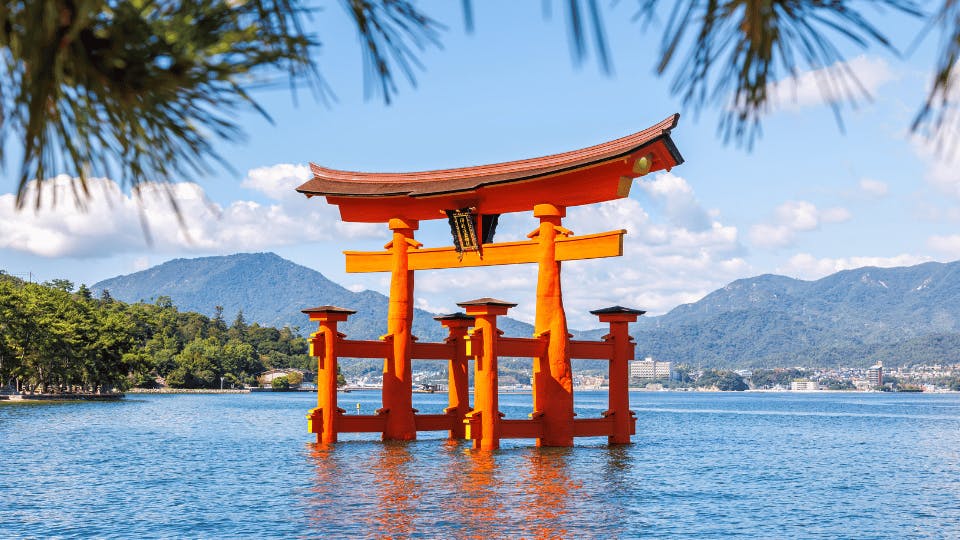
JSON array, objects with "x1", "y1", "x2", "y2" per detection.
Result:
[{"x1": 308, "y1": 441, "x2": 608, "y2": 538}]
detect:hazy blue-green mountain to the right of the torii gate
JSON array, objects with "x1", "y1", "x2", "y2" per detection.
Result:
[{"x1": 635, "y1": 262, "x2": 960, "y2": 367}]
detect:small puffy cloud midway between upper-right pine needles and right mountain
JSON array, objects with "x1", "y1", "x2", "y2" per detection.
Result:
[{"x1": 749, "y1": 201, "x2": 851, "y2": 248}]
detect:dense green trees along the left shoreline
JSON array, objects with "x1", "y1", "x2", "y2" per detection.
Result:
[{"x1": 0, "y1": 272, "x2": 316, "y2": 392}]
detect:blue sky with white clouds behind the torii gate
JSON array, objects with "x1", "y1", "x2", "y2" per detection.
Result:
[{"x1": 0, "y1": 1, "x2": 960, "y2": 328}]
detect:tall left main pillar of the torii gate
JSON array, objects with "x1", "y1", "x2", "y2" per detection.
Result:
[{"x1": 382, "y1": 219, "x2": 420, "y2": 441}]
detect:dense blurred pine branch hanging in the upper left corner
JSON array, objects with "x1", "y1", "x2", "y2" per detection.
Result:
[{"x1": 0, "y1": 0, "x2": 316, "y2": 207}]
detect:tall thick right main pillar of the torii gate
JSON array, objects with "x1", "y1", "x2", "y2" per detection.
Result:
[{"x1": 528, "y1": 204, "x2": 574, "y2": 446}]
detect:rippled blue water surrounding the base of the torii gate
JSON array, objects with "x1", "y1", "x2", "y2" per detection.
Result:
[{"x1": 0, "y1": 392, "x2": 960, "y2": 539}]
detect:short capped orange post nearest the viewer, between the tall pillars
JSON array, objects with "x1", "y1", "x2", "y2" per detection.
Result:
[{"x1": 457, "y1": 298, "x2": 516, "y2": 450}]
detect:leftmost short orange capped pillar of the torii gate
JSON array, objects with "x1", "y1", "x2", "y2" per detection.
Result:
[{"x1": 303, "y1": 306, "x2": 356, "y2": 443}]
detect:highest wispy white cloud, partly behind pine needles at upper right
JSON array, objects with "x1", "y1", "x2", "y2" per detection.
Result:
[{"x1": 767, "y1": 55, "x2": 897, "y2": 110}]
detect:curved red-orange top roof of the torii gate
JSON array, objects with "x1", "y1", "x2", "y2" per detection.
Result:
[{"x1": 297, "y1": 114, "x2": 683, "y2": 223}]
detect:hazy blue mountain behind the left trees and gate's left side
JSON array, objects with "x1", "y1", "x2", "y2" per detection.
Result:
[{"x1": 92, "y1": 253, "x2": 533, "y2": 341}]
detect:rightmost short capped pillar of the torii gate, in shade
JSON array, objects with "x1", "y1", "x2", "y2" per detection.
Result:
[{"x1": 590, "y1": 306, "x2": 646, "y2": 444}]
